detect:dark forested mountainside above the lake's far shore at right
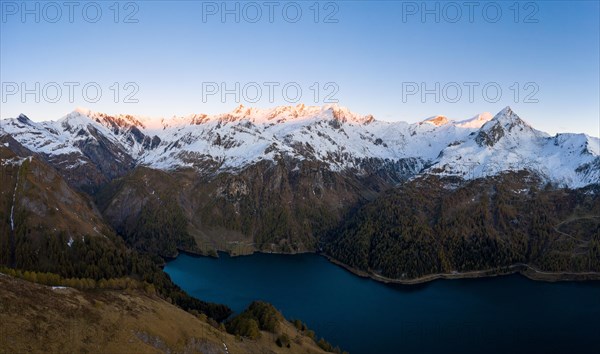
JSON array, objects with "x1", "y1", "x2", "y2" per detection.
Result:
[{"x1": 325, "y1": 174, "x2": 600, "y2": 279}]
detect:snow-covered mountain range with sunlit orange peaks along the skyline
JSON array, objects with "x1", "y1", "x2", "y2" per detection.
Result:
[{"x1": 0, "y1": 105, "x2": 600, "y2": 194}]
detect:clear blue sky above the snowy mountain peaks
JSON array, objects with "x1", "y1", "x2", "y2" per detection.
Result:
[{"x1": 0, "y1": 0, "x2": 600, "y2": 136}]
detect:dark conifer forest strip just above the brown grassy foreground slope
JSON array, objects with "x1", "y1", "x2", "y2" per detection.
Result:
[{"x1": 2, "y1": 221, "x2": 231, "y2": 321}]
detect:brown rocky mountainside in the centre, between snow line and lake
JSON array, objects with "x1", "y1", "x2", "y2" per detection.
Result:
[{"x1": 97, "y1": 160, "x2": 418, "y2": 253}]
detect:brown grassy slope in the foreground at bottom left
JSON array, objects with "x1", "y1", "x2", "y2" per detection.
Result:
[{"x1": 0, "y1": 275, "x2": 324, "y2": 353}]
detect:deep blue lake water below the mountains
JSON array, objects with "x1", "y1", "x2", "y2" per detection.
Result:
[{"x1": 165, "y1": 254, "x2": 600, "y2": 354}]
